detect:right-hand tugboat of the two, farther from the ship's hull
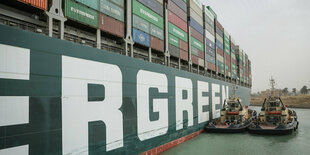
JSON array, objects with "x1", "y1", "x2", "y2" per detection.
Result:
[{"x1": 249, "y1": 78, "x2": 299, "y2": 134}]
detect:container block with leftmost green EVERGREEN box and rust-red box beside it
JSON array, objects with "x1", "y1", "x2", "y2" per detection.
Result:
[{"x1": 64, "y1": 0, "x2": 124, "y2": 38}]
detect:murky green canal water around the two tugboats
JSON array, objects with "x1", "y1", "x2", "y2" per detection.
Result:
[{"x1": 163, "y1": 107, "x2": 310, "y2": 155}]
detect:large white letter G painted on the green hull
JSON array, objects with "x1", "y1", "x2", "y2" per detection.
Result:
[{"x1": 137, "y1": 70, "x2": 169, "y2": 141}]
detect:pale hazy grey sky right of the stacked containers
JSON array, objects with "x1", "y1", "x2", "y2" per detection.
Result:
[{"x1": 202, "y1": 0, "x2": 310, "y2": 92}]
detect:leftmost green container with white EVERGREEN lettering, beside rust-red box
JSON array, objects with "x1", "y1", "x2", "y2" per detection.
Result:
[{"x1": 65, "y1": 0, "x2": 99, "y2": 28}]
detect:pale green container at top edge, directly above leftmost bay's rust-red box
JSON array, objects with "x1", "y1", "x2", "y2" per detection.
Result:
[{"x1": 100, "y1": 0, "x2": 124, "y2": 22}]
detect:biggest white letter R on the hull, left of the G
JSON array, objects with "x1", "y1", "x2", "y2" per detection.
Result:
[{"x1": 62, "y1": 56, "x2": 123, "y2": 154}]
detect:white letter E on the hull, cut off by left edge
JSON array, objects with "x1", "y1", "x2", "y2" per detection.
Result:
[{"x1": 0, "y1": 44, "x2": 30, "y2": 155}]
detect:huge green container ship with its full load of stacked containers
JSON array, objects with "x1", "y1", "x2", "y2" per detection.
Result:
[{"x1": 0, "y1": 0, "x2": 252, "y2": 155}]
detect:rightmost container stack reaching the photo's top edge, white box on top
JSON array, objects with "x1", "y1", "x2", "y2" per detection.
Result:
[{"x1": 189, "y1": 0, "x2": 205, "y2": 67}]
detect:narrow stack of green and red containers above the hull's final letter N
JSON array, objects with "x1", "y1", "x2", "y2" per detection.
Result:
[{"x1": 224, "y1": 30, "x2": 231, "y2": 77}]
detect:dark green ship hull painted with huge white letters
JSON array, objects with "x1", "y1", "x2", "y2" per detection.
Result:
[{"x1": 0, "y1": 25, "x2": 251, "y2": 155}]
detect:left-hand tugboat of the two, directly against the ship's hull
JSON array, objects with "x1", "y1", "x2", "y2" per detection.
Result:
[{"x1": 205, "y1": 85, "x2": 256, "y2": 133}]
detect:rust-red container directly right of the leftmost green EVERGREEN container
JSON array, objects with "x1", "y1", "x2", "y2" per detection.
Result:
[{"x1": 99, "y1": 13, "x2": 125, "y2": 38}]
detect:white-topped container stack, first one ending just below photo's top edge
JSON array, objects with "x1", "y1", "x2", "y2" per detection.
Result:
[{"x1": 204, "y1": 6, "x2": 216, "y2": 71}]
